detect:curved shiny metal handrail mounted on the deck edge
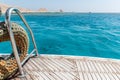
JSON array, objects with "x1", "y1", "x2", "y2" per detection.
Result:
[{"x1": 5, "y1": 8, "x2": 39, "y2": 76}]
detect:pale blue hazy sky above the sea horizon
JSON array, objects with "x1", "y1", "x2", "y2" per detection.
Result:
[{"x1": 0, "y1": 0, "x2": 120, "y2": 12}]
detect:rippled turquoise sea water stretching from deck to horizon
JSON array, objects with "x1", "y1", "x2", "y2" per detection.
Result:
[{"x1": 0, "y1": 13, "x2": 120, "y2": 59}]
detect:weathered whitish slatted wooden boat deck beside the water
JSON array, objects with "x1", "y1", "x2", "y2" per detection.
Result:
[{"x1": 12, "y1": 55, "x2": 120, "y2": 80}]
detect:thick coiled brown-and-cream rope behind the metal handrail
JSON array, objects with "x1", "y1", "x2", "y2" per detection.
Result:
[{"x1": 0, "y1": 22, "x2": 29, "y2": 80}]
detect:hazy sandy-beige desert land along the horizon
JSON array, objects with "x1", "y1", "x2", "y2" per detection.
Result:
[{"x1": 0, "y1": 3, "x2": 63, "y2": 13}]
